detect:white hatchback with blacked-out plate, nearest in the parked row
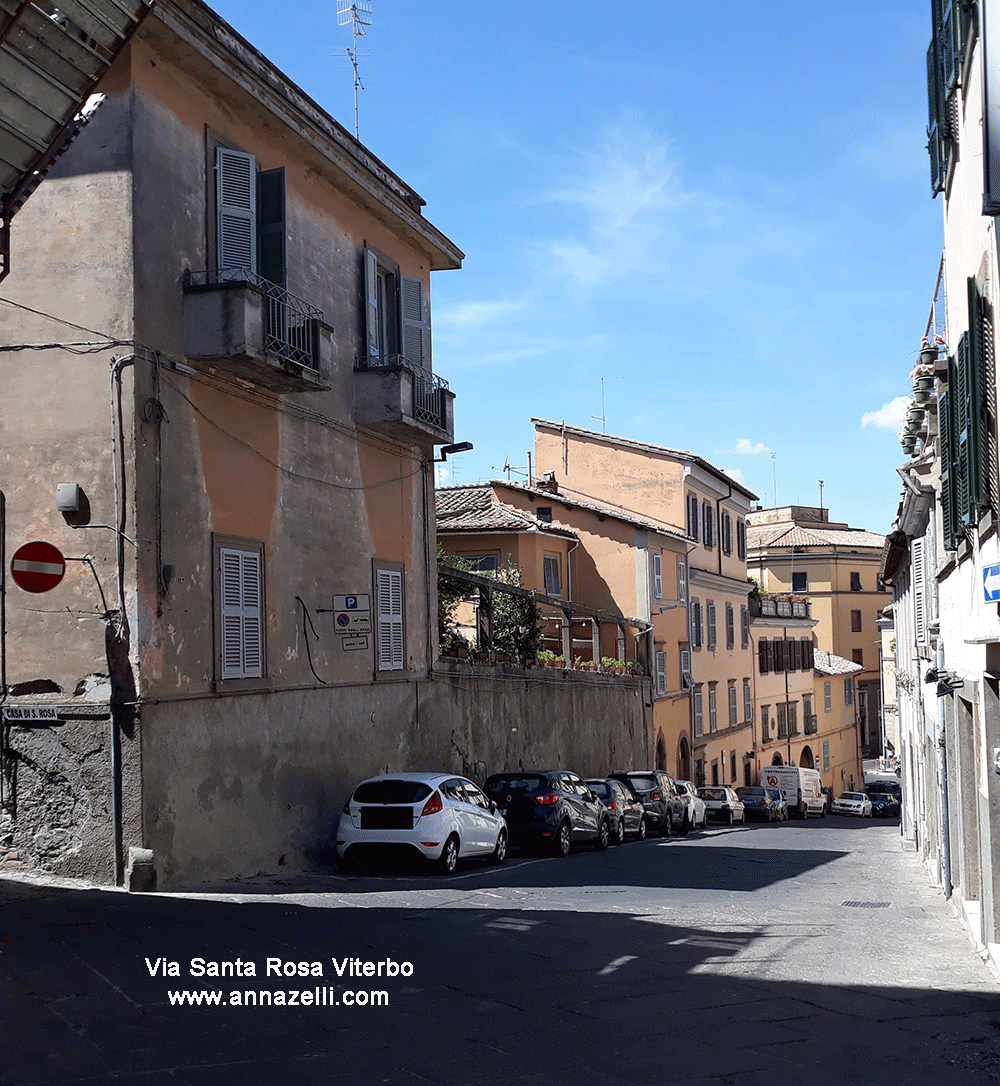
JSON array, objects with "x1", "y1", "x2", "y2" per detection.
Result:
[{"x1": 337, "y1": 773, "x2": 507, "y2": 874}]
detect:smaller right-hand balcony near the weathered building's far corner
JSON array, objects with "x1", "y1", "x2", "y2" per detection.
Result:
[{"x1": 354, "y1": 354, "x2": 455, "y2": 445}]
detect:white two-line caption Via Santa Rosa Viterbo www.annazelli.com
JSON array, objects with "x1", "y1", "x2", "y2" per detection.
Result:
[{"x1": 144, "y1": 958, "x2": 414, "y2": 1008}]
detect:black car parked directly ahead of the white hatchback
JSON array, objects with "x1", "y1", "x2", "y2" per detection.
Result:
[{"x1": 483, "y1": 769, "x2": 611, "y2": 856}]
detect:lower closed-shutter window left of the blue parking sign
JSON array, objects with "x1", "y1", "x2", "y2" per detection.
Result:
[{"x1": 214, "y1": 539, "x2": 265, "y2": 681}]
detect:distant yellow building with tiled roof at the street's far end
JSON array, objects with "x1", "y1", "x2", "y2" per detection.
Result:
[{"x1": 747, "y1": 505, "x2": 890, "y2": 756}]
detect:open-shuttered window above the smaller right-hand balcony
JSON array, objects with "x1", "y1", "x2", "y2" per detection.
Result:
[{"x1": 365, "y1": 249, "x2": 431, "y2": 369}]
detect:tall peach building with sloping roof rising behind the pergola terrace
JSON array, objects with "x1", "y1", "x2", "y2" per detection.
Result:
[{"x1": 532, "y1": 418, "x2": 757, "y2": 781}]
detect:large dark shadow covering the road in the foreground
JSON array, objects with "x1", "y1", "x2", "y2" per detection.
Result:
[{"x1": 0, "y1": 877, "x2": 1000, "y2": 1086}]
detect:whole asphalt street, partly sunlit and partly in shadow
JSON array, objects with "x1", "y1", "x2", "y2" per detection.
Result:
[{"x1": 0, "y1": 818, "x2": 1000, "y2": 1086}]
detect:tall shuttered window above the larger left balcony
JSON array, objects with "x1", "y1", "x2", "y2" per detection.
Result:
[{"x1": 215, "y1": 147, "x2": 286, "y2": 288}]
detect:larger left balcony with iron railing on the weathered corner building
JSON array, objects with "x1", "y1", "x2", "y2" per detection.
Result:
[{"x1": 183, "y1": 268, "x2": 333, "y2": 392}]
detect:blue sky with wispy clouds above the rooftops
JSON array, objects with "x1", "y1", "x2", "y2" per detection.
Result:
[{"x1": 214, "y1": 0, "x2": 942, "y2": 531}]
